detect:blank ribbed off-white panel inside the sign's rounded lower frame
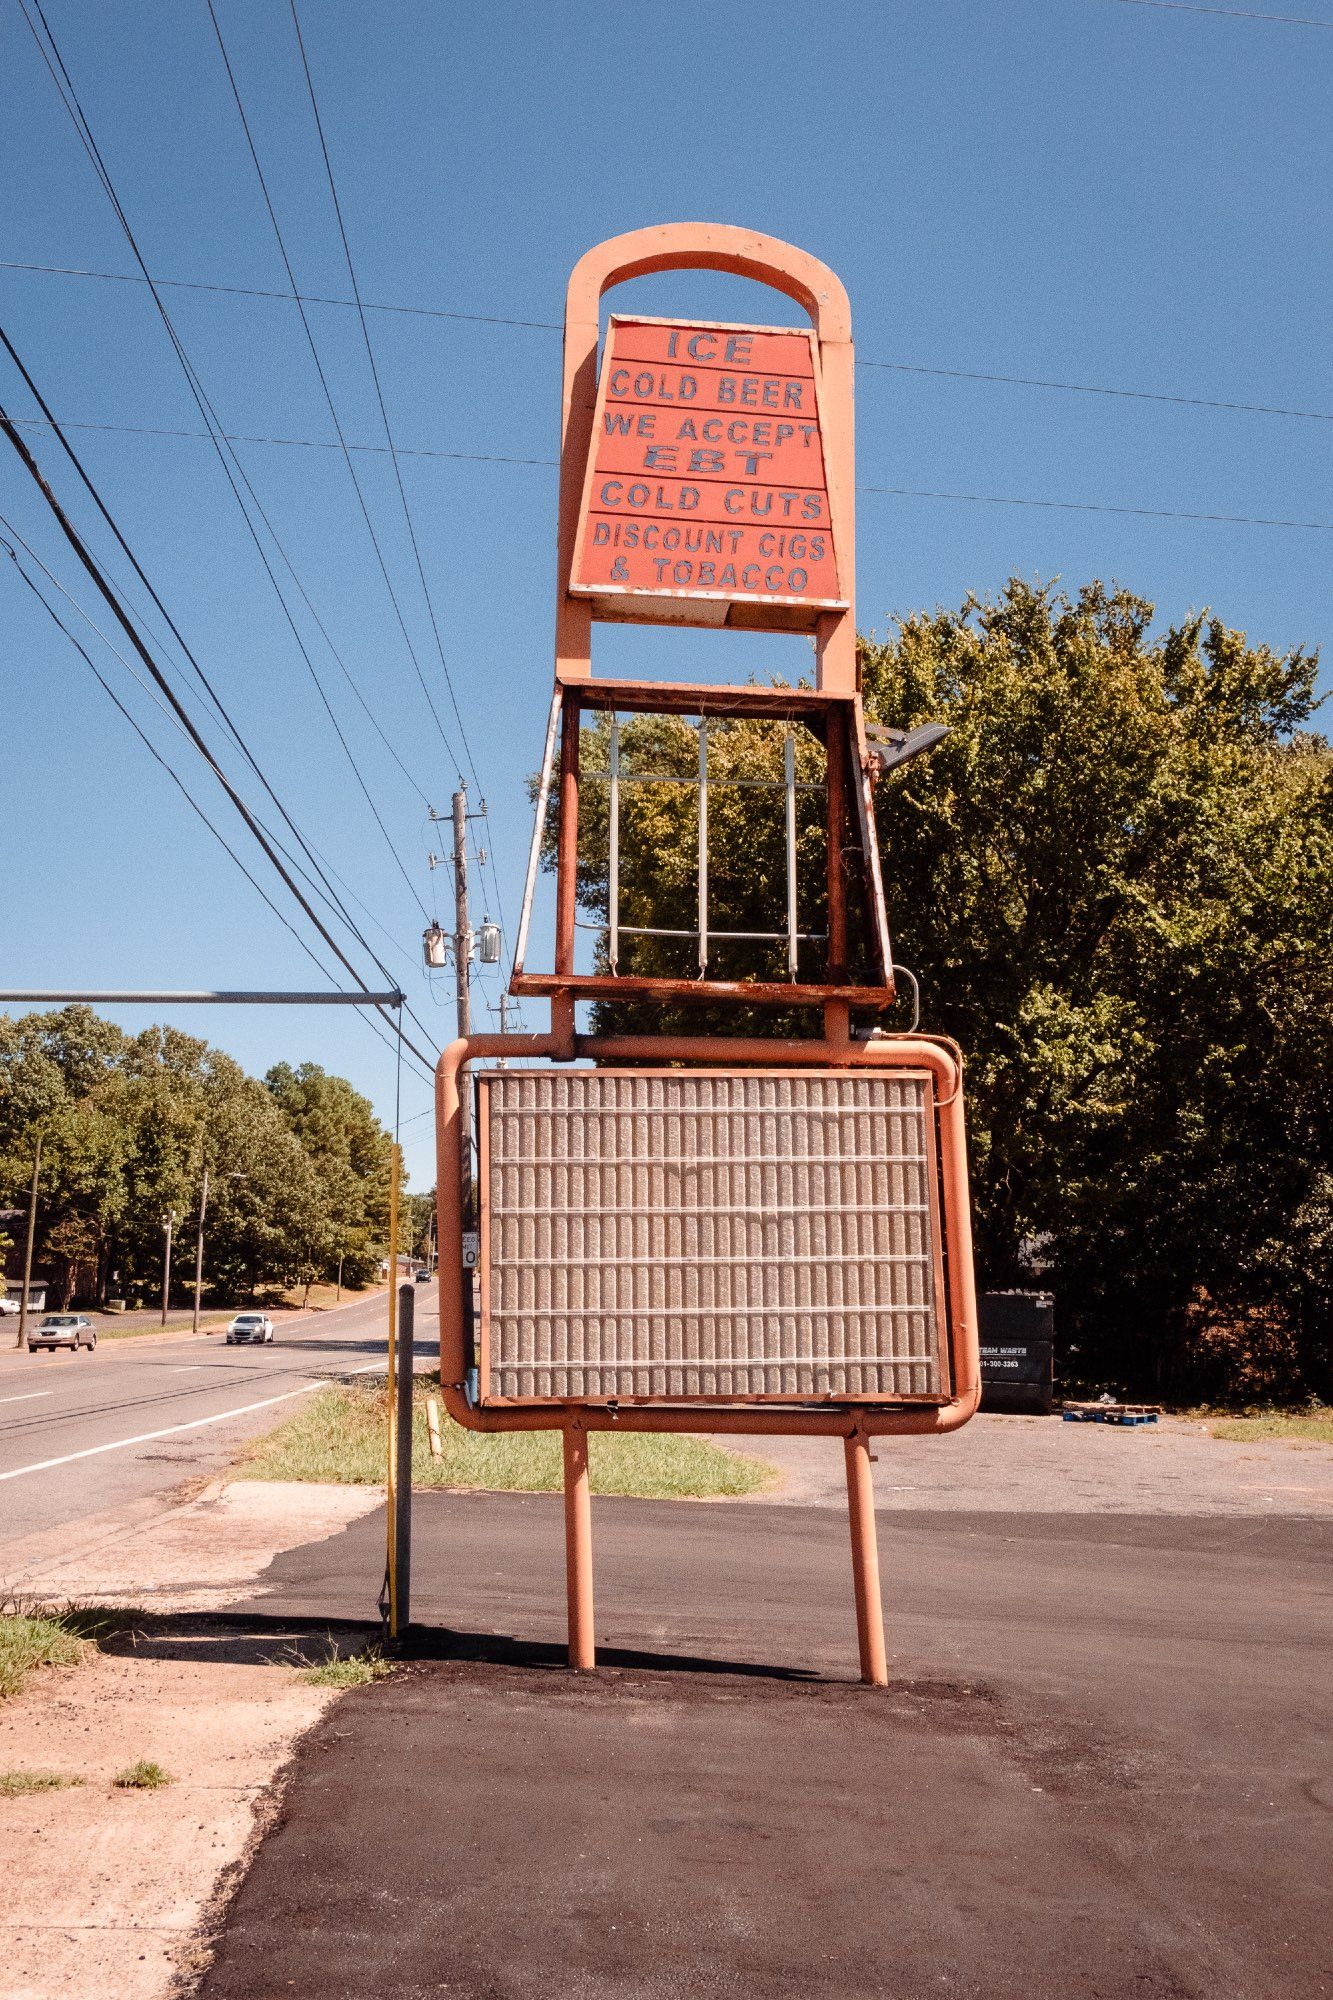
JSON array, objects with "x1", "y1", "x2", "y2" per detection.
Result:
[{"x1": 478, "y1": 1070, "x2": 949, "y2": 1402}]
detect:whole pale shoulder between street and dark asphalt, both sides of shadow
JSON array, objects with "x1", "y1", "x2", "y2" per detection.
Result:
[{"x1": 0, "y1": 1480, "x2": 382, "y2": 2000}]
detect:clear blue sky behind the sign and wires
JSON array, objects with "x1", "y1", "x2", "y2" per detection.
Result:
[{"x1": 0, "y1": 0, "x2": 1333, "y2": 1186}]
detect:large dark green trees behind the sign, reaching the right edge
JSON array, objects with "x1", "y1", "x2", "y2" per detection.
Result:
[{"x1": 564, "y1": 578, "x2": 1333, "y2": 1398}]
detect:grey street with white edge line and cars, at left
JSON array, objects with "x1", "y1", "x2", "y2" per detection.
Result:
[{"x1": 0, "y1": 1286, "x2": 438, "y2": 1558}]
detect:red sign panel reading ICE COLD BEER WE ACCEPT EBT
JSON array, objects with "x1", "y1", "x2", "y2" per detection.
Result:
[{"x1": 570, "y1": 318, "x2": 845, "y2": 626}]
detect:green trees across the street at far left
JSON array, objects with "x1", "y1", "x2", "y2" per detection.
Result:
[{"x1": 0, "y1": 1006, "x2": 392, "y2": 1306}]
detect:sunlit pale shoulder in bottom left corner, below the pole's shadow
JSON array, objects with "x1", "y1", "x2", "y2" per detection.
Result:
[{"x1": 0, "y1": 1654, "x2": 332, "y2": 2000}]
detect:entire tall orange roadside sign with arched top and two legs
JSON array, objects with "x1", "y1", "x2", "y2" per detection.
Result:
[{"x1": 436, "y1": 224, "x2": 981, "y2": 1682}]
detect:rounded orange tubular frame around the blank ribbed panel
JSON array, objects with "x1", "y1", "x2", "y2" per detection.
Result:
[{"x1": 436, "y1": 1032, "x2": 981, "y2": 1438}]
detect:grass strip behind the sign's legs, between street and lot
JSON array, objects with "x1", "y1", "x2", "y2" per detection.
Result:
[{"x1": 236, "y1": 1376, "x2": 777, "y2": 1500}]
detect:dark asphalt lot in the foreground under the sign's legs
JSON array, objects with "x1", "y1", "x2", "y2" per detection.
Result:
[{"x1": 197, "y1": 1494, "x2": 1333, "y2": 2000}]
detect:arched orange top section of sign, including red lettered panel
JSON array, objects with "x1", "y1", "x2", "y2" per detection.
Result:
[{"x1": 556, "y1": 222, "x2": 857, "y2": 696}]
